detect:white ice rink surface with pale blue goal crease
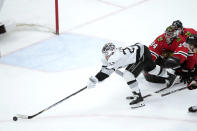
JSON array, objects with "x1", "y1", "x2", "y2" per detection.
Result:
[{"x1": 0, "y1": 0, "x2": 197, "y2": 131}]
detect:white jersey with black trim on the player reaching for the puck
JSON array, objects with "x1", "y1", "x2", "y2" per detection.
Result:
[{"x1": 96, "y1": 43, "x2": 144, "y2": 81}]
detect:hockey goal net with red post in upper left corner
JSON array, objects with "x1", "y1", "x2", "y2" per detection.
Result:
[{"x1": 0, "y1": 0, "x2": 59, "y2": 34}]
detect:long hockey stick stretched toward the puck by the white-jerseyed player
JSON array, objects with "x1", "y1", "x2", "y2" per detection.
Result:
[{"x1": 13, "y1": 86, "x2": 87, "y2": 121}]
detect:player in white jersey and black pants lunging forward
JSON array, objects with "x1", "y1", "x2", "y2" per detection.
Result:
[{"x1": 87, "y1": 43, "x2": 172, "y2": 108}]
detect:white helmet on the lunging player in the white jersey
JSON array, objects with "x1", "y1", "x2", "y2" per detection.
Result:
[{"x1": 102, "y1": 43, "x2": 116, "y2": 60}]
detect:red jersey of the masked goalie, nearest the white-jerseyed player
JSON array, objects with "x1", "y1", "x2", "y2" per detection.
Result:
[{"x1": 149, "y1": 34, "x2": 188, "y2": 63}]
